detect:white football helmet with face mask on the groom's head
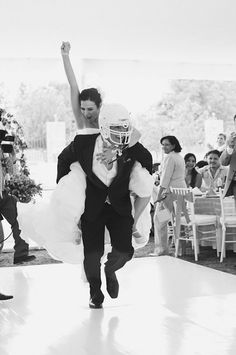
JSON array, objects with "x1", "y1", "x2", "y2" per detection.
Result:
[{"x1": 99, "y1": 104, "x2": 132, "y2": 147}]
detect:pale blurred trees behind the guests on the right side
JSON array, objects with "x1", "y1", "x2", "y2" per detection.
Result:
[{"x1": 136, "y1": 80, "x2": 236, "y2": 155}]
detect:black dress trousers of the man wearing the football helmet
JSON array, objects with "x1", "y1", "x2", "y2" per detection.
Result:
[{"x1": 81, "y1": 203, "x2": 134, "y2": 296}]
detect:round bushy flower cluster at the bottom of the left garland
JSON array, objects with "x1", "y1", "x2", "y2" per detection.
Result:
[{"x1": 5, "y1": 174, "x2": 42, "y2": 203}]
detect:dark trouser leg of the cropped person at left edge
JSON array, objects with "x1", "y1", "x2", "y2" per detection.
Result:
[{"x1": 0, "y1": 191, "x2": 29, "y2": 258}]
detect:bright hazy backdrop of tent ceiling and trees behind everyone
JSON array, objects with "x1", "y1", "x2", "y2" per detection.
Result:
[{"x1": 0, "y1": 0, "x2": 236, "y2": 189}]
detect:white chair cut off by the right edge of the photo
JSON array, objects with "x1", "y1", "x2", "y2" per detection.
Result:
[{"x1": 219, "y1": 189, "x2": 236, "y2": 263}]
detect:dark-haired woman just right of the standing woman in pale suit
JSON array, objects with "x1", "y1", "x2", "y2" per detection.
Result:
[{"x1": 184, "y1": 153, "x2": 202, "y2": 188}]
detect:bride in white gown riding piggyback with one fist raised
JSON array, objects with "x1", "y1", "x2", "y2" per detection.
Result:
[{"x1": 18, "y1": 43, "x2": 153, "y2": 263}]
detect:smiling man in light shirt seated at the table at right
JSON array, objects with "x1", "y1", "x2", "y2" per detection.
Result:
[{"x1": 198, "y1": 150, "x2": 228, "y2": 191}]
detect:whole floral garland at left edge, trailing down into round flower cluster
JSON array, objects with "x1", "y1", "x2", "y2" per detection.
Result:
[{"x1": 0, "y1": 108, "x2": 42, "y2": 202}]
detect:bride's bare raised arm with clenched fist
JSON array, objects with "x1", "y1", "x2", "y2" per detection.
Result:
[{"x1": 61, "y1": 42, "x2": 85, "y2": 129}]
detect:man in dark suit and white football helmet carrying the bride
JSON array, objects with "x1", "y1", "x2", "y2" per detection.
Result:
[{"x1": 57, "y1": 104, "x2": 152, "y2": 308}]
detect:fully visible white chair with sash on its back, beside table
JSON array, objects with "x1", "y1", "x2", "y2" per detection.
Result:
[{"x1": 170, "y1": 187, "x2": 219, "y2": 261}]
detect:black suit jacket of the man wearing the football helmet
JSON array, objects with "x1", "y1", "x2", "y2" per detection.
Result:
[{"x1": 57, "y1": 134, "x2": 152, "y2": 221}]
